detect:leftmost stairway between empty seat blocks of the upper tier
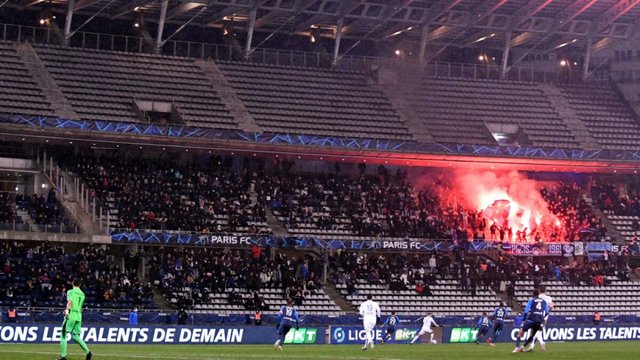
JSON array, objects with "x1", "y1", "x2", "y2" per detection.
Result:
[{"x1": 16, "y1": 42, "x2": 80, "y2": 119}]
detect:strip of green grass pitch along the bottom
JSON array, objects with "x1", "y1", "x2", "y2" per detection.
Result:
[{"x1": 0, "y1": 341, "x2": 640, "y2": 360}]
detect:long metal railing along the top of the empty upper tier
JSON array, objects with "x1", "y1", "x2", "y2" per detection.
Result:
[{"x1": 0, "y1": 24, "x2": 604, "y2": 83}]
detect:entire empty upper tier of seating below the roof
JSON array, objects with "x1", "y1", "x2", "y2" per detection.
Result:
[{"x1": 0, "y1": 43, "x2": 640, "y2": 150}]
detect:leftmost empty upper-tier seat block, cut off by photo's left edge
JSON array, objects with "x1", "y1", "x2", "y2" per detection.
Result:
[{"x1": 0, "y1": 42, "x2": 53, "y2": 116}]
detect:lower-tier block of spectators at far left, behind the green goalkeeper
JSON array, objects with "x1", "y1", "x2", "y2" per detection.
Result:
[{"x1": 0, "y1": 241, "x2": 152, "y2": 308}]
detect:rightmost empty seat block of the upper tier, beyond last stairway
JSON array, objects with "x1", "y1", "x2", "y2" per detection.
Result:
[{"x1": 560, "y1": 84, "x2": 640, "y2": 150}]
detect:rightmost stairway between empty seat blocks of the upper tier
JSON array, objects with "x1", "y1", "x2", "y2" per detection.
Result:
[{"x1": 539, "y1": 84, "x2": 602, "y2": 150}]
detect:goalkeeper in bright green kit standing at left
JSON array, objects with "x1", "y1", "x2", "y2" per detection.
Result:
[{"x1": 58, "y1": 279, "x2": 93, "y2": 360}]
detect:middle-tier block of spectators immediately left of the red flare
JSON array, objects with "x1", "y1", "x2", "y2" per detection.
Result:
[{"x1": 256, "y1": 166, "x2": 450, "y2": 239}]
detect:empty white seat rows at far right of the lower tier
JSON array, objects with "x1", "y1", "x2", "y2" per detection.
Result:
[{"x1": 516, "y1": 278, "x2": 640, "y2": 315}]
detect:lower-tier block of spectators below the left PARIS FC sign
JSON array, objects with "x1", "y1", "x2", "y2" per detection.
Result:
[{"x1": 145, "y1": 246, "x2": 322, "y2": 310}]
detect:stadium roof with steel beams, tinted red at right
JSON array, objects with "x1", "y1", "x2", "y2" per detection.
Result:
[{"x1": 5, "y1": 0, "x2": 640, "y2": 60}]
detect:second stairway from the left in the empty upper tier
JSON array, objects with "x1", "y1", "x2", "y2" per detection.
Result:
[{"x1": 195, "y1": 58, "x2": 261, "y2": 132}]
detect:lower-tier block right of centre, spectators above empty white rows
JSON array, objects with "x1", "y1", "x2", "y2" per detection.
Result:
[{"x1": 331, "y1": 252, "x2": 500, "y2": 316}]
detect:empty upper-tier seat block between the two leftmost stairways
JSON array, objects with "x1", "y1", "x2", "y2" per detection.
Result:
[{"x1": 35, "y1": 46, "x2": 237, "y2": 129}]
